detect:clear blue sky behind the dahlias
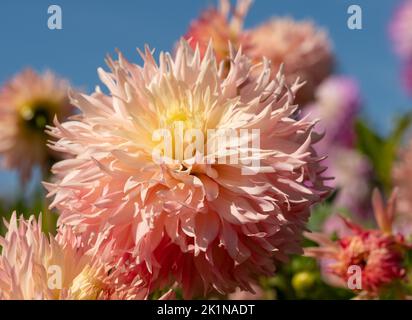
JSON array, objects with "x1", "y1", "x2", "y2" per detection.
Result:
[{"x1": 0, "y1": 0, "x2": 412, "y2": 198}]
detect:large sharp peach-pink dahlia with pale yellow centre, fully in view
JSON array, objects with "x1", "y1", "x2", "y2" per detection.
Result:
[{"x1": 45, "y1": 40, "x2": 328, "y2": 298}]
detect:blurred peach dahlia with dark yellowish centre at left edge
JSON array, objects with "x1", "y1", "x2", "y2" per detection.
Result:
[{"x1": 0, "y1": 69, "x2": 73, "y2": 182}]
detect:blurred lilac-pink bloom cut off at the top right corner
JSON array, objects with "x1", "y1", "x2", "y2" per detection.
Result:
[{"x1": 389, "y1": 0, "x2": 412, "y2": 60}]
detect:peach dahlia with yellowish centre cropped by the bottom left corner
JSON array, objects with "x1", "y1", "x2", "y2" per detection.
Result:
[{"x1": 0, "y1": 213, "x2": 154, "y2": 300}]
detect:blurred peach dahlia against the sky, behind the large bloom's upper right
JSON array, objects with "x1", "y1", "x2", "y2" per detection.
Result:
[{"x1": 245, "y1": 18, "x2": 333, "y2": 105}]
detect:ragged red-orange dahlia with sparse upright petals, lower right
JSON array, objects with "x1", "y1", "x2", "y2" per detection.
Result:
[{"x1": 305, "y1": 189, "x2": 410, "y2": 298}]
